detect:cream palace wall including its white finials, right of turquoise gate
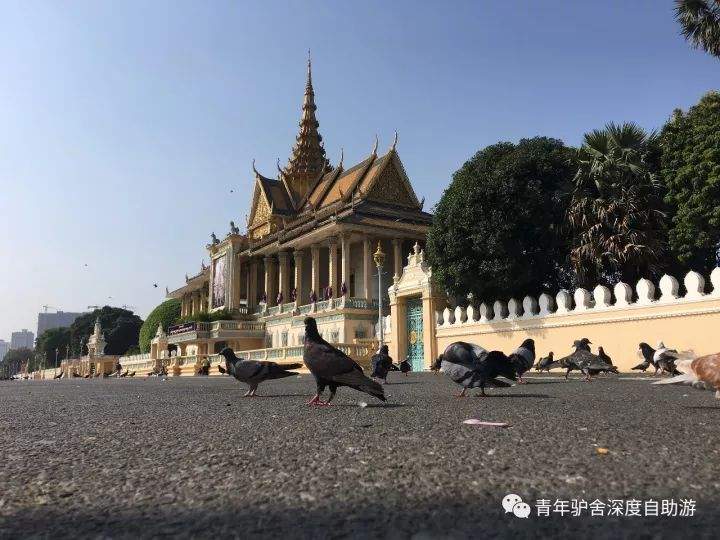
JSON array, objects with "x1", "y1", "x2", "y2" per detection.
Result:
[{"x1": 425, "y1": 268, "x2": 720, "y2": 371}]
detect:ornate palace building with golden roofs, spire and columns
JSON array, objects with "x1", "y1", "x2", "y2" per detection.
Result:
[{"x1": 162, "y1": 60, "x2": 431, "y2": 362}]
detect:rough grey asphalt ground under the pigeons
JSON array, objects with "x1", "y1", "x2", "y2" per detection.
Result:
[{"x1": 0, "y1": 374, "x2": 720, "y2": 539}]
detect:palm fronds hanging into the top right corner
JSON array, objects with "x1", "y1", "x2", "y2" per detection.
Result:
[{"x1": 675, "y1": 0, "x2": 720, "y2": 57}]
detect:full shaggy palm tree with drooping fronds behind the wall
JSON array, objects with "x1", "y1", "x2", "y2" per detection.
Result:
[{"x1": 568, "y1": 123, "x2": 665, "y2": 285}]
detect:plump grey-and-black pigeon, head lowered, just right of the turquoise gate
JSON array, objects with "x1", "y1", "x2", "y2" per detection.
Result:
[{"x1": 438, "y1": 341, "x2": 517, "y2": 397}]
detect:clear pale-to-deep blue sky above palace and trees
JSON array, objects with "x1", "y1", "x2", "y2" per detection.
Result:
[{"x1": 0, "y1": 0, "x2": 720, "y2": 339}]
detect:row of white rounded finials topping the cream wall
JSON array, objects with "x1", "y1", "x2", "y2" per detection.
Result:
[{"x1": 436, "y1": 267, "x2": 720, "y2": 328}]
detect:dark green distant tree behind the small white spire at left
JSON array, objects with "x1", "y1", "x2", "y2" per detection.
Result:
[{"x1": 70, "y1": 306, "x2": 143, "y2": 354}]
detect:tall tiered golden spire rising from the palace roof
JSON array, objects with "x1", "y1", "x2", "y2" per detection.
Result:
[{"x1": 281, "y1": 50, "x2": 332, "y2": 202}]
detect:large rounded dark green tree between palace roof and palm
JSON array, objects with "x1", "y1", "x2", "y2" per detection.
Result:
[{"x1": 427, "y1": 137, "x2": 574, "y2": 301}]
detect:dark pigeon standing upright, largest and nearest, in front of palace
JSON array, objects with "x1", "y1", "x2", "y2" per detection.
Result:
[{"x1": 303, "y1": 317, "x2": 385, "y2": 405}]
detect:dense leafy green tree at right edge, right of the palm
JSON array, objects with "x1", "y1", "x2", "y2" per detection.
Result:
[{"x1": 660, "y1": 92, "x2": 720, "y2": 272}]
